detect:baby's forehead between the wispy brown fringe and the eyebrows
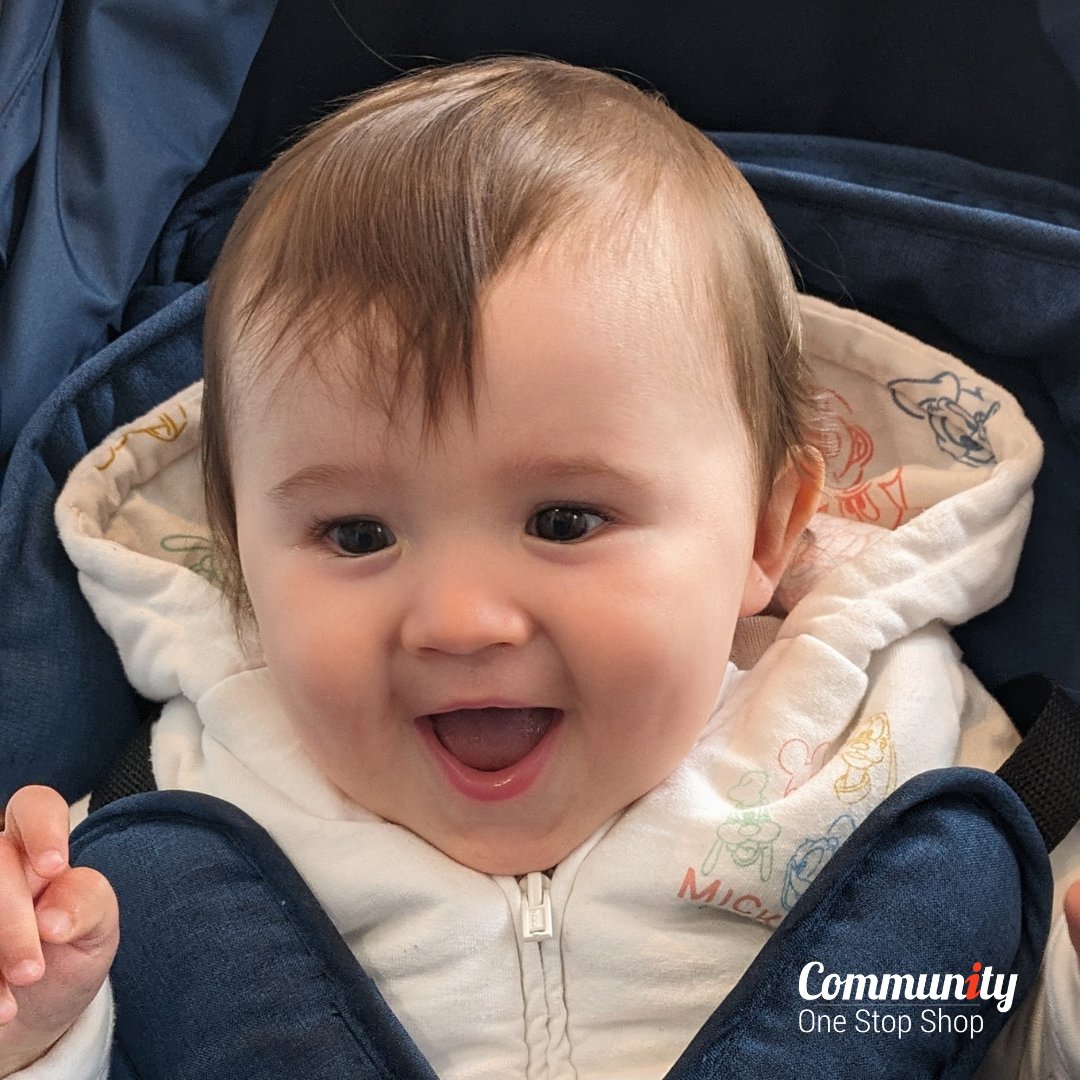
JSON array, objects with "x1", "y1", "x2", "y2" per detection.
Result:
[{"x1": 226, "y1": 275, "x2": 748, "y2": 505}]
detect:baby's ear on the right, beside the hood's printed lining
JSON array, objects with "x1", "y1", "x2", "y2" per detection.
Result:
[{"x1": 739, "y1": 446, "x2": 825, "y2": 617}]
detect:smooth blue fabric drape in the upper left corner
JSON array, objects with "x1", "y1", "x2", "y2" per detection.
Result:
[{"x1": 0, "y1": 0, "x2": 274, "y2": 459}]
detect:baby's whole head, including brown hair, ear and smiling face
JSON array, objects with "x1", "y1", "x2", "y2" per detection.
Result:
[{"x1": 203, "y1": 59, "x2": 820, "y2": 873}]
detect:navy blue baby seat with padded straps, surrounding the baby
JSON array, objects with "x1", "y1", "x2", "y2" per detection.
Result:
[{"x1": 0, "y1": 0, "x2": 1080, "y2": 1080}]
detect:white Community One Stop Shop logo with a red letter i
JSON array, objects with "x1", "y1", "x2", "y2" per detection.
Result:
[{"x1": 798, "y1": 960, "x2": 1016, "y2": 1039}]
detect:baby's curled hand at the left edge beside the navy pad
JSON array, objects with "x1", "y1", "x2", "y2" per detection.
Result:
[{"x1": 0, "y1": 787, "x2": 120, "y2": 1077}]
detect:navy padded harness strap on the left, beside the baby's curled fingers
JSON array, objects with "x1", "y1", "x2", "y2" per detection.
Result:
[{"x1": 71, "y1": 792, "x2": 438, "y2": 1080}]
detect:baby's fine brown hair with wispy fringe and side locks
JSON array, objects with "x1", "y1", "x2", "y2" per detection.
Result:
[{"x1": 202, "y1": 58, "x2": 814, "y2": 616}]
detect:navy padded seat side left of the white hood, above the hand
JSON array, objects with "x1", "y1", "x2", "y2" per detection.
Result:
[{"x1": 0, "y1": 287, "x2": 203, "y2": 805}]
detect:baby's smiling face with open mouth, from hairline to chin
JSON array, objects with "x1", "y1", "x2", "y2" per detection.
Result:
[{"x1": 233, "y1": 249, "x2": 769, "y2": 874}]
